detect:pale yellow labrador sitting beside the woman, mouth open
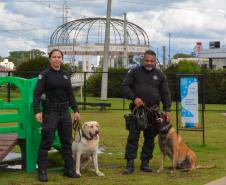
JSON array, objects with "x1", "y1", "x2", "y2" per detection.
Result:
[{"x1": 72, "y1": 121, "x2": 104, "y2": 176}]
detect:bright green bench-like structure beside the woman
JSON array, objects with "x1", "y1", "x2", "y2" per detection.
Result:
[{"x1": 0, "y1": 76, "x2": 60, "y2": 172}]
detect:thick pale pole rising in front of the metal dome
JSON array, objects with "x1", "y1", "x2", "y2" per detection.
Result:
[{"x1": 101, "y1": 0, "x2": 111, "y2": 100}]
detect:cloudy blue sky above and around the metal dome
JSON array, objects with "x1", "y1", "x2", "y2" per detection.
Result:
[{"x1": 0, "y1": 0, "x2": 226, "y2": 61}]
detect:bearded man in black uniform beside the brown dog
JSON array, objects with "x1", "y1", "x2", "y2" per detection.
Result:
[{"x1": 122, "y1": 50, "x2": 171, "y2": 174}]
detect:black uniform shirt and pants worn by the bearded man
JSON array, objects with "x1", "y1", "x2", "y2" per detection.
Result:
[{"x1": 122, "y1": 66, "x2": 171, "y2": 161}]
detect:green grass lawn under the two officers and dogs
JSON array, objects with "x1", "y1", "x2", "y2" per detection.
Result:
[{"x1": 0, "y1": 110, "x2": 226, "y2": 185}]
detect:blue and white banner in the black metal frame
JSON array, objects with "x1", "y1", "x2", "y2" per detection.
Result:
[{"x1": 180, "y1": 77, "x2": 199, "y2": 128}]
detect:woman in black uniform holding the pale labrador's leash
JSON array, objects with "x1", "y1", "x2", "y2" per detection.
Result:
[{"x1": 33, "y1": 49, "x2": 80, "y2": 181}]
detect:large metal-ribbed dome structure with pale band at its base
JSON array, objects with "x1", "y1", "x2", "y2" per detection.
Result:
[{"x1": 48, "y1": 17, "x2": 150, "y2": 56}]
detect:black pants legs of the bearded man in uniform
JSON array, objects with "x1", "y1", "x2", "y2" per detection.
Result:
[{"x1": 125, "y1": 110, "x2": 158, "y2": 161}]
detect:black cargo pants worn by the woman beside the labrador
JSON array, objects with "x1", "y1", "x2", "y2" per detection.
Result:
[{"x1": 37, "y1": 103, "x2": 74, "y2": 171}]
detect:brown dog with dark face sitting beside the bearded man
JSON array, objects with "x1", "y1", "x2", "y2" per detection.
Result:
[{"x1": 156, "y1": 114, "x2": 216, "y2": 173}]
